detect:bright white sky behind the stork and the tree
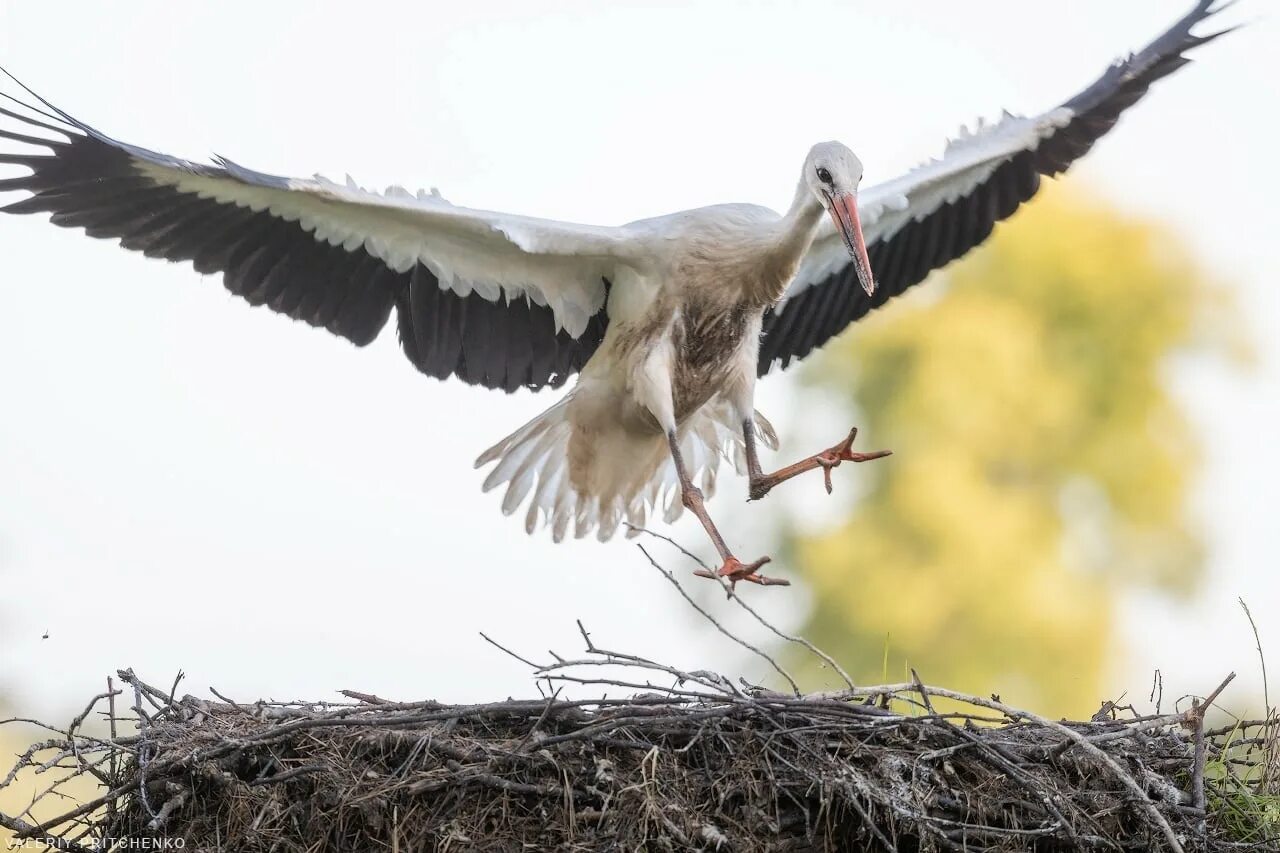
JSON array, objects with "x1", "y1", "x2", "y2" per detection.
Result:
[{"x1": 0, "y1": 0, "x2": 1280, "y2": 716}]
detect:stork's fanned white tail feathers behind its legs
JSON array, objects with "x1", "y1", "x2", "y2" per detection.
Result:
[{"x1": 476, "y1": 394, "x2": 778, "y2": 542}]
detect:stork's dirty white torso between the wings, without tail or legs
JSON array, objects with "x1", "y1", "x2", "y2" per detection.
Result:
[{"x1": 581, "y1": 204, "x2": 822, "y2": 473}]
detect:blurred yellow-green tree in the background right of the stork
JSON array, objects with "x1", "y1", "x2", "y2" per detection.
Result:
[{"x1": 783, "y1": 187, "x2": 1230, "y2": 713}]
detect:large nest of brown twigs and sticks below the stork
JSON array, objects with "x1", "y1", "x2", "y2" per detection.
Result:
[{"x1": 0, "y1": 647, "x2": 1274, "y2": 853}]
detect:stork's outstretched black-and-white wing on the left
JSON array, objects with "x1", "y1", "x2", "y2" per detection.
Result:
[{"x1": 0, "y1": 81, "x2": 625, "y2": 392}]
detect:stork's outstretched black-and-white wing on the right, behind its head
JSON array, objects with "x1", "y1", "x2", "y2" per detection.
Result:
[{"x1": 758, "y1": 0, "x2": 1229, "y2": 375}]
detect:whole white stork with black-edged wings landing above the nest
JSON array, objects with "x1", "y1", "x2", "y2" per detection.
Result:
[{"x1": 0, "y1": 0, "x2": 1225, "y2": 584}]
